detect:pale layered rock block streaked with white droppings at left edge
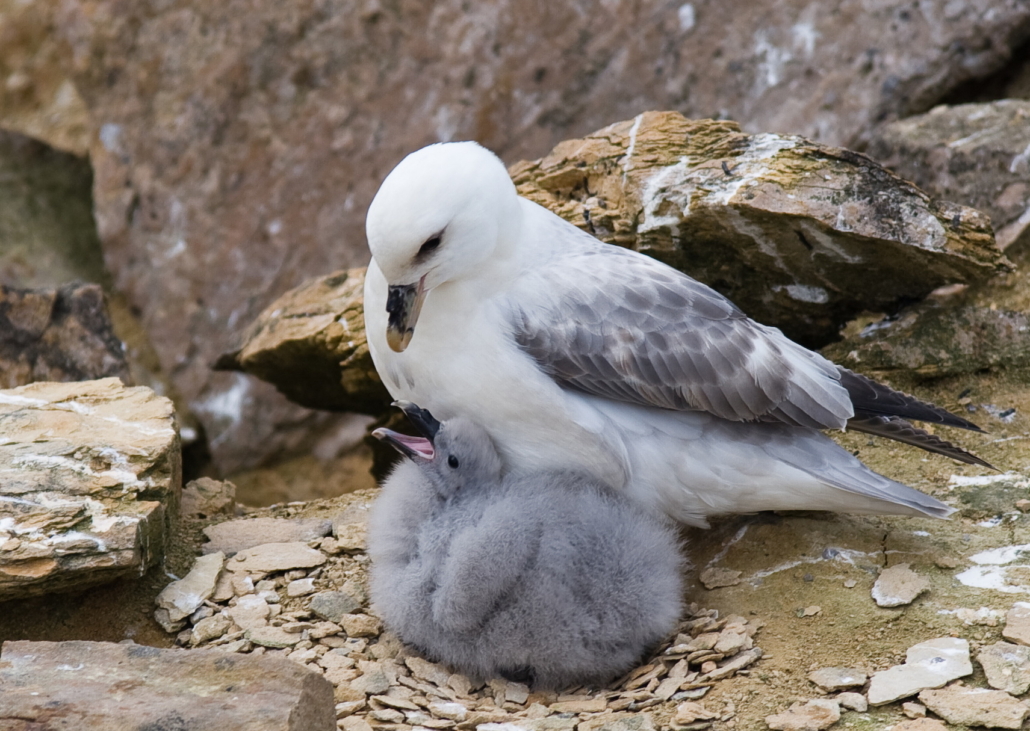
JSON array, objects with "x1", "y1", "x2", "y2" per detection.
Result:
[{"x1": 0, "y1": 378, "x2": 181, "y2": 599}]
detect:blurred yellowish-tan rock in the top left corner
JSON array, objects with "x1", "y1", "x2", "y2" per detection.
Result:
[{"x1": 0, "y1": 0, "x2": 91, "y2": 155}]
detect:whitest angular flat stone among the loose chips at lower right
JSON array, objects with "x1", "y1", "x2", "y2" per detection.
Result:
[{"x1": 867, "y1": 637, "x2": 972, "y2": 705}]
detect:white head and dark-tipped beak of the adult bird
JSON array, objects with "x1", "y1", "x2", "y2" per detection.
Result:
[{"x1": 365, "y1": 142, "x2": 520, "y2": 352}]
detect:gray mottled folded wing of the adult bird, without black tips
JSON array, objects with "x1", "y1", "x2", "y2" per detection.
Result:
[{"x1": 512, "y1": 241, "x2": 854, "y2": 428}]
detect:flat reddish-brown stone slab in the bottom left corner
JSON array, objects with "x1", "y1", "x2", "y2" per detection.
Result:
[{"x1": 0, "y1": 641, "x2": 336, "y2": 731}]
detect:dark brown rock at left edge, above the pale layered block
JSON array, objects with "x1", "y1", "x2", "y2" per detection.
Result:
[{"x1": 0, "y1": 284, "x2": 130, "y2": 388}]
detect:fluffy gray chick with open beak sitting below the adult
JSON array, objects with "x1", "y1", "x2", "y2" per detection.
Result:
[{"x1": 369, "y1": 403, "x2": 684, "y2": 689}]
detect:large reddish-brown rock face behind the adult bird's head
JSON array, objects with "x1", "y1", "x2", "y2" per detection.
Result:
[{"x1": 59, "y1": 0, "x2": 1030, "y2": 469}]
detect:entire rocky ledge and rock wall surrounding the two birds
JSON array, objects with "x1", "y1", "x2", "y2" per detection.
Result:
[{"x1": 0, "y1": 0, "x2": 1030, "y2": 731}]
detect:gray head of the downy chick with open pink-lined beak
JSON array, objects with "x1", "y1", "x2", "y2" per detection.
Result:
[{"x1": 372, "y1": 402, "x2": 502, "y2": 499}]
